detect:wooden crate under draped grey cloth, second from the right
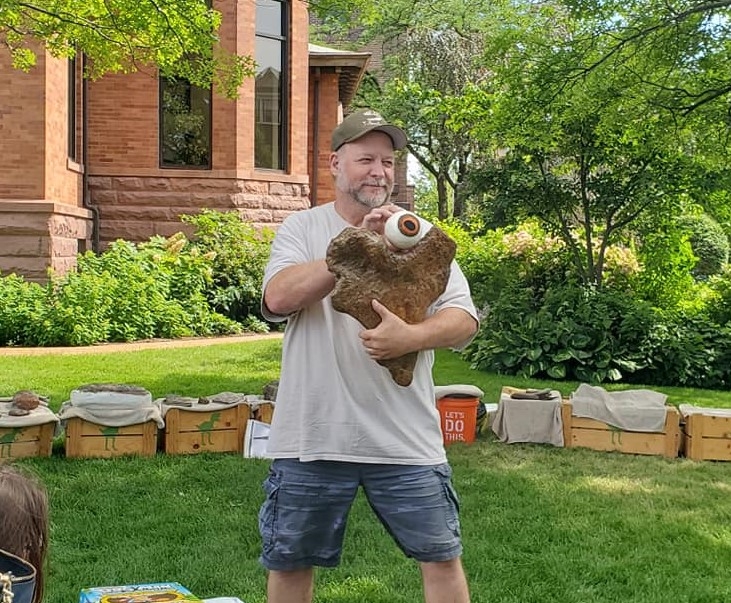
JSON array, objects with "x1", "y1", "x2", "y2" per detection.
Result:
[{"x1": 561, "y1": 401, "x2": 680, "y2": 458}]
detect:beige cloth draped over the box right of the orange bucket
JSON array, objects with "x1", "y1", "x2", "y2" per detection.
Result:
[{"x1": 492, "y1": 390, "x2": 564, "y2": 446}]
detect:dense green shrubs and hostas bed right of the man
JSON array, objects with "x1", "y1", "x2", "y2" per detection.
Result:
[{"x1": 460, "y1": 224, "x2": 731, "y2": 388}]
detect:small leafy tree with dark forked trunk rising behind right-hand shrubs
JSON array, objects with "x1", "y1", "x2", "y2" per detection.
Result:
[{"x1": 459, "y1": 4, "x2": 712, "y2": 286}]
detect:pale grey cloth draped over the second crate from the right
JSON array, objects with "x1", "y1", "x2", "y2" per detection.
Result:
[{"x1": 571, "y1": 383, "x2": 667, "y2": 433}]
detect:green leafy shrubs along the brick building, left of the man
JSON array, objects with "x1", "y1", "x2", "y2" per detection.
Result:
[{"x1": 0, "y1": 211, "x2": 271, "y2": 346}]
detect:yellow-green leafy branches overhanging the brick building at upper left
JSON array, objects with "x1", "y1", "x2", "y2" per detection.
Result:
[{"x1": 0, "y1": 0, "x2": 253, "y2": 97}]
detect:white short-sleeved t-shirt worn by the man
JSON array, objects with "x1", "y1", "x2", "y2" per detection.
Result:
[{"x1": 262, "y1": 203, "x2": 477, "y2": 465}]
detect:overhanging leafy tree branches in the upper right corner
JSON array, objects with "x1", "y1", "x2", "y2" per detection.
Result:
[{"x1": 564, "y1": 0, "x2": 731, "y2": 125}]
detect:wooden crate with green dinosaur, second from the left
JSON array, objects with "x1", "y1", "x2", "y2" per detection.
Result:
[{"x1": 66, "y1": 417, "x2": 157, "y2": 457}]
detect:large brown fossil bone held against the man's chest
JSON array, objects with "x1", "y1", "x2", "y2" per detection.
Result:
[{"x1": 326, "y1": 226, "x2": 457, "y2": 386}]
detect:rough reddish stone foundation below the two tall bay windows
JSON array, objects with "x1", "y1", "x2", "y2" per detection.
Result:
[{"x1": 89, "y1": 176, "x2": 310, "y2": 247}]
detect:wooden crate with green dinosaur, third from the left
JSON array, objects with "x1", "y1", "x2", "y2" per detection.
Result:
[{"x1": 165, "y1": 404, "x2": 251, "y2": 454}]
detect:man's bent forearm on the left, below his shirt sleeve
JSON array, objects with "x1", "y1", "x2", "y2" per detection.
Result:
[{"x1": 264, "y1": 260, "x2": 335, "y2": 316}]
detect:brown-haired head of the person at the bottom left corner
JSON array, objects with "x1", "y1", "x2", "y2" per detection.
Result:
[{"x1": 0, "y1": 465, "x2": 48, "y2": 603}]
